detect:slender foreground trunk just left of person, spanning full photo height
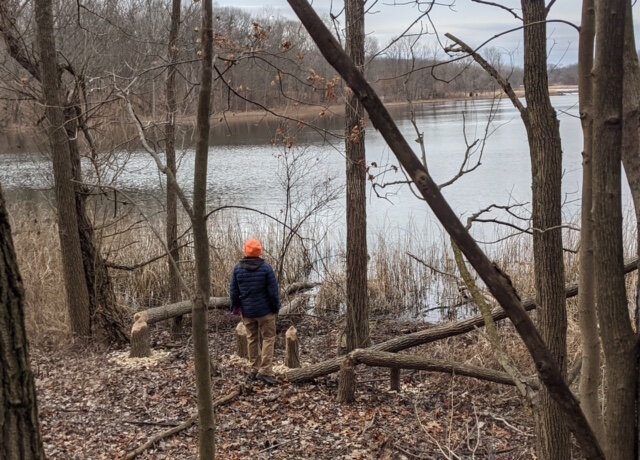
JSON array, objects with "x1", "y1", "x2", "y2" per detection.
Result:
[{"x1": 191, "y1": 0, "x2": 215, "y2": 454}]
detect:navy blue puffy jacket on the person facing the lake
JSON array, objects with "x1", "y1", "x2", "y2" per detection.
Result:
[{"x1": 229, "y1": 257, "x2": 280, "y2": 318}]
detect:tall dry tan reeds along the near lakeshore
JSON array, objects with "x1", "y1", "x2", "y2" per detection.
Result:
[{"x1": 11, "y1": 199, "x2": 635, "y2": 354}]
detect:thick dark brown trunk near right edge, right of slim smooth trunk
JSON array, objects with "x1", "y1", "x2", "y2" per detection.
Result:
[{"x1": 593, "y1": 0, "x2": 637, "y2": 460}]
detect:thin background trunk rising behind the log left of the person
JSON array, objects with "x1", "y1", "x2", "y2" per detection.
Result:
[{"x1": 165, "y1": 0, "x2": 182, "y2": 334}]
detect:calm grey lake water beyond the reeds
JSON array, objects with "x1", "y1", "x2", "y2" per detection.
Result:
[{"x1": 0, "y1": 94, "x2": 630, "y2": 246}]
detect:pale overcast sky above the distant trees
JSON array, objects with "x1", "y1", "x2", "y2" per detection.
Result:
[{"x1": 216, "y1": 0, "x2": 640, "y2": 65}]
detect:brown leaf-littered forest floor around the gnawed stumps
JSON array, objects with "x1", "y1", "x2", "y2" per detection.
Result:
[{"x1": 32, "y1": 312, "x2": 534, "y2": 459}]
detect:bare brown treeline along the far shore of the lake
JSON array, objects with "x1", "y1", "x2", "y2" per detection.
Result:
[{"x1": 0, "y1": 0, "x2": 577, "y2": 125}]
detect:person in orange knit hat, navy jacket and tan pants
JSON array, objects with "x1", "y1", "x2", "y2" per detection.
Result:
[{"x1": 229, "y1": 239, "x2": 280, "y2": 385}]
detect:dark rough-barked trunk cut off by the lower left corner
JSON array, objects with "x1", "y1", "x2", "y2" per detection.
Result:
[{"x1": 0, "y1": 184, "x2": 45, "y2": 460}]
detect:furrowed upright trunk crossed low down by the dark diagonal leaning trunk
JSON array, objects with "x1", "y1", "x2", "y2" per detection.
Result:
[{"x1": 522, "y1": 0, "x2": 570, "y2": 460}]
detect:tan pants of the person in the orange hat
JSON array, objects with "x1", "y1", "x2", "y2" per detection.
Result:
[{"x1": 242, "y1": 313, "x2": 276, "y2": 375}]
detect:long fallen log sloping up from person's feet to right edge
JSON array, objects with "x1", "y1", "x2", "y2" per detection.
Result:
[{"x1": 287, "y1": 257, "x2": 638, "y2": 382}]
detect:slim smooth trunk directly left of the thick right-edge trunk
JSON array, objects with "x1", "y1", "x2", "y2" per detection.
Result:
[{"x1": 578, "y1": 0, "x2": 604, "y2": 442}]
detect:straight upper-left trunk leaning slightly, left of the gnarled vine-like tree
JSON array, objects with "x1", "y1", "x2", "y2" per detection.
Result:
[{"x1": 35, "y1": 0, "x2": 91, "y2": 338}]
